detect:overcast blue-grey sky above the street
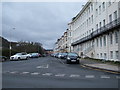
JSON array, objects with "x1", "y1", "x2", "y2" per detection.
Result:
[{"x1": 2, "y1": 2, "x2": 85, "y2": 49}]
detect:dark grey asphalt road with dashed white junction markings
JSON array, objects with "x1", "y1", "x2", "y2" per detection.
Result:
[{"x1": 2, "y1": 56, "x2": 119, "y2": 88}]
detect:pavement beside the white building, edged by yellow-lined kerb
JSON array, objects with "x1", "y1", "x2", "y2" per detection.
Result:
[{"x1": 80, "y1": 59, "x2": 120, "y2": 74}]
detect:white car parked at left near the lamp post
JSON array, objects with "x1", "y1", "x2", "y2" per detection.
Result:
[{"x1": 10, "y1": 53, "x2": 28, "y2": 60}]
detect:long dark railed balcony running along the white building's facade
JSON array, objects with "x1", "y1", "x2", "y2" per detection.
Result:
[{"x1": 72, "y1": 18, "x2": 120, "y2": 46}]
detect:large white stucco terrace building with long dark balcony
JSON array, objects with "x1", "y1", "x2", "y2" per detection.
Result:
[{"x1": 69, "y1": 0, "x2": 120, "y2": 61}]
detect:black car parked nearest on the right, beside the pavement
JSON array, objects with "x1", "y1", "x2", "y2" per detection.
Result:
[{"x1": 66, "y1": 53, "x2": 79, "y2": 64}]
